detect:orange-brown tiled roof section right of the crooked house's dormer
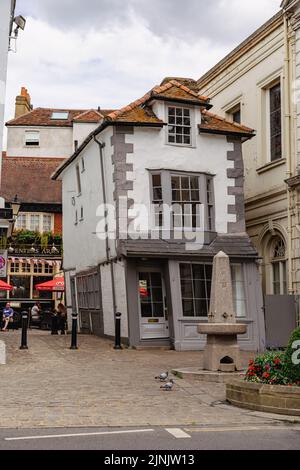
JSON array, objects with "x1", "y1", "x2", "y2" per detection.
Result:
[{"x1": 199, "y1": 111, "x2": 254, "y2": 137}]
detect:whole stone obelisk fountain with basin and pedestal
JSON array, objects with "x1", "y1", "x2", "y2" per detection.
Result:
[{"x1": 198, "y1": 251, "x2": 247, "y2": 372}]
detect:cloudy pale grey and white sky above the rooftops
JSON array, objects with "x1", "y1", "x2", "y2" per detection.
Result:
[{"x1": 6, "y1": 0, "x2": 281, "y2": 129}]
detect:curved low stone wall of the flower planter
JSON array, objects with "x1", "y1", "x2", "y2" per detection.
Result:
[{"x1": 226, "y1": 379, "x2": 300, "y2": 416}]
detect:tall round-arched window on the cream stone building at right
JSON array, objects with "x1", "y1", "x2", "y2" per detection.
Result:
[{"x1": 271, "y1": 236, "x2": 287, "y2": 295}]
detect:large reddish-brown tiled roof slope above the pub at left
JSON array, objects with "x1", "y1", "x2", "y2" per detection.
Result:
[{"x1": 0, "y1": 155, "x2": 63, "y2": 204}]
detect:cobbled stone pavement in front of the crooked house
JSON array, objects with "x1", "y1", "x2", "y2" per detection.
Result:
[{"x1": 0, "y1": 330, "x2": 296, "y2": 428}]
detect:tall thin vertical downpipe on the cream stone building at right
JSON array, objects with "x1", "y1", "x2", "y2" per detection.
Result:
[{"x1": 283, "y1": 10, "x2": 294, "y2": 295}]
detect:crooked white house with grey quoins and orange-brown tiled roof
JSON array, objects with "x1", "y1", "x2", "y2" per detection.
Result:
[{"x1": 53, "y1": 79, "x2": 265, "y2": 351}]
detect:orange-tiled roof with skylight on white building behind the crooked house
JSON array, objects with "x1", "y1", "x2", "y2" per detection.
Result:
[{"x1": 7, "y1": 108, "x2": 115, "y2": 127}]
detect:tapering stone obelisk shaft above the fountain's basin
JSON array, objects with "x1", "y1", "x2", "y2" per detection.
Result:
[{"x1": 209, "y1": 251, "x2": 236, "y2": 323}]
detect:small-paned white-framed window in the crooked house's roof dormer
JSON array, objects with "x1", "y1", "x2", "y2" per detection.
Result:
[{"x1": 168, "y1": 106, "x2": 192, "y2": 146}]
